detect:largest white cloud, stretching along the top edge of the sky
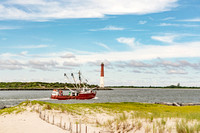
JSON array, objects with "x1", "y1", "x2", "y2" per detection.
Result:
[{"x1": 0, "y1": 0, "x2": 178, "y2": 21}]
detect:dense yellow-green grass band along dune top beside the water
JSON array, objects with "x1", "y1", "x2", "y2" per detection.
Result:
[{"x1": 14, "y1": 101, "x2": 200, "y2": 120}]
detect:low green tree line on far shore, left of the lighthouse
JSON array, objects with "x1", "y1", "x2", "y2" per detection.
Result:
[{"x1": 0, "y1": 82, "x2": 98, "y2": 89}]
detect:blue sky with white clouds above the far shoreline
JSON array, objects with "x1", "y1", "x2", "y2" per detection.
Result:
[{"x1": 0, "y1": 0, "x2": 200, "y2": 86}]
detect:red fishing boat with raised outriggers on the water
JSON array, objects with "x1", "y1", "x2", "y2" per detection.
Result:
[{"x1": 51, "y1": 71, "x2": 96, "y2": 100}]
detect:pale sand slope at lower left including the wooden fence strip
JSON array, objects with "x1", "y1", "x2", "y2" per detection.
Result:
[{"x1": 0, "y1": 105, "x2": 101, "y2": 133}]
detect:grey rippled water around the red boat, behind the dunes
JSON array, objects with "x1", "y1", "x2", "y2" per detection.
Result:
[{"x1": 0, "y1": 89, "x2": 200, "y2": 106}]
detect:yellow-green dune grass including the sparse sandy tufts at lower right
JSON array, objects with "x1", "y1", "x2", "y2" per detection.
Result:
[{"x1": 0, "y1": 101, "x2": 200, "y2": 133}]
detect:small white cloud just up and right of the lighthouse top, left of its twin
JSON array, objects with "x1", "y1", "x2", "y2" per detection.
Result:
[{"x1": 117, "y1": 37, "x2": 140, "y2": 48}]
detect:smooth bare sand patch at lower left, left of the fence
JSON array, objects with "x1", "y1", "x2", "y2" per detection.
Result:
[{"x1": 0, "y1": 111, "x2": 66, "y2": 133}]
